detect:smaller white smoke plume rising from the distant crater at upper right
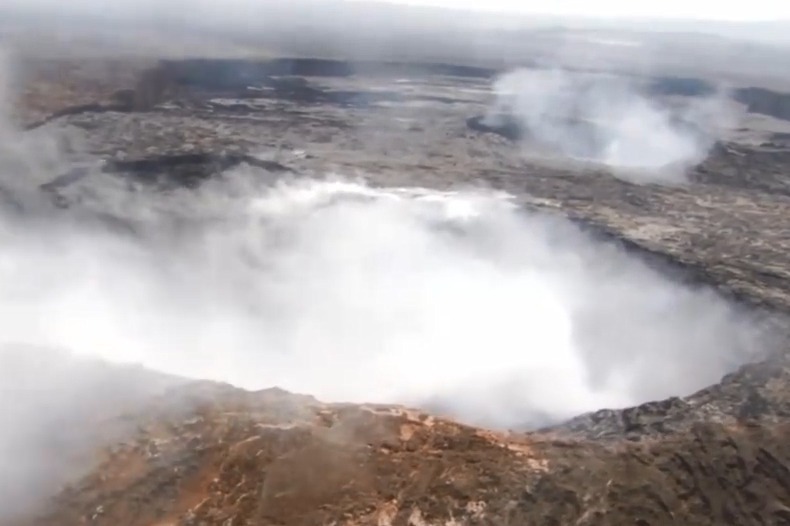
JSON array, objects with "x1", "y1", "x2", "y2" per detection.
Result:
[{"x1": 487, "y1": 69, "x2": 727, "y2": 182}]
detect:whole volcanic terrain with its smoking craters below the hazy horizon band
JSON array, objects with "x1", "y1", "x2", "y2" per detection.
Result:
[{"x1": 0, "y1": 11, "x2": 790, "y2": 525}]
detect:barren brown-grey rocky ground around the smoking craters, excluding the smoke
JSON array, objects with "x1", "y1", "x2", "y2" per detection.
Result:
[{"x1": 0, "y1": 36, "x2": 790, "y2": 526}]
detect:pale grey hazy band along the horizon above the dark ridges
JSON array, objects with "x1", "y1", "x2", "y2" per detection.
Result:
[{"x1": 0, "y1": 0, "x2": 790, "y2": 84}]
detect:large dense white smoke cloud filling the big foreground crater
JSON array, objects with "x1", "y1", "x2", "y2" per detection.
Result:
[{"x1": 0, "y1": 166, "x2": 772, "y2": 426}]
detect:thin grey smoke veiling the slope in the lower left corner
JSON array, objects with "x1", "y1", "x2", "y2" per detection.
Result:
[{"x1": 0, "y1": 345, "x2": 186, "y2": 524}]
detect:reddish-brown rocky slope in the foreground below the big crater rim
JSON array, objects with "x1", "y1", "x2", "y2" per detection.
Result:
[{"x1": 15, "y1": 385, "x2": 790, "y2": 526}]
